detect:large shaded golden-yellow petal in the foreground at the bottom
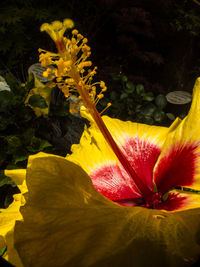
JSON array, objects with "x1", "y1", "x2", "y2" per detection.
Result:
[{"x1": 11, "y1": 154, "x2": 200, "y2": 267}]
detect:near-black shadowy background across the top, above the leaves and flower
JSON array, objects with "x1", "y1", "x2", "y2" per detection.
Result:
[{"x1": 0, "y1": 0, "x2": 200, "y2": 93}]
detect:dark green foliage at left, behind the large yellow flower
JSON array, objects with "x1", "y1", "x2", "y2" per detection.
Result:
[{"x1": 0, "y1": 73, "x2": 84, "y2": 208}]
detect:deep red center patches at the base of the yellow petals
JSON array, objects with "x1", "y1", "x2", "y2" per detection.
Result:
[{"x1": 90, "y1": 138, "x2": 198, "y2": 210}]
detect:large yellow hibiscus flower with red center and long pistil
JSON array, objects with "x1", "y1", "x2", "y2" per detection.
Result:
[{"x1": 1, "y1": 19, "x2": 200, "y2": 267}]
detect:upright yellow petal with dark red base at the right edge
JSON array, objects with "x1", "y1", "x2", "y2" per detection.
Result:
[{"x1": 154, "y1": 78, "x2": 200, "y2": 192}]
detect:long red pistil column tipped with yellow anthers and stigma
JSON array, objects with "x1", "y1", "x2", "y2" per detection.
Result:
[{"x1": 40, "y1": 20, "x2": 157, "y2": 203}]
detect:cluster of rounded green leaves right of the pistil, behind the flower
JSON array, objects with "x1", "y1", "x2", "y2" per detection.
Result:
[{"x1": 99, "y1": 73, "x2": 175, "y2": 125}]
